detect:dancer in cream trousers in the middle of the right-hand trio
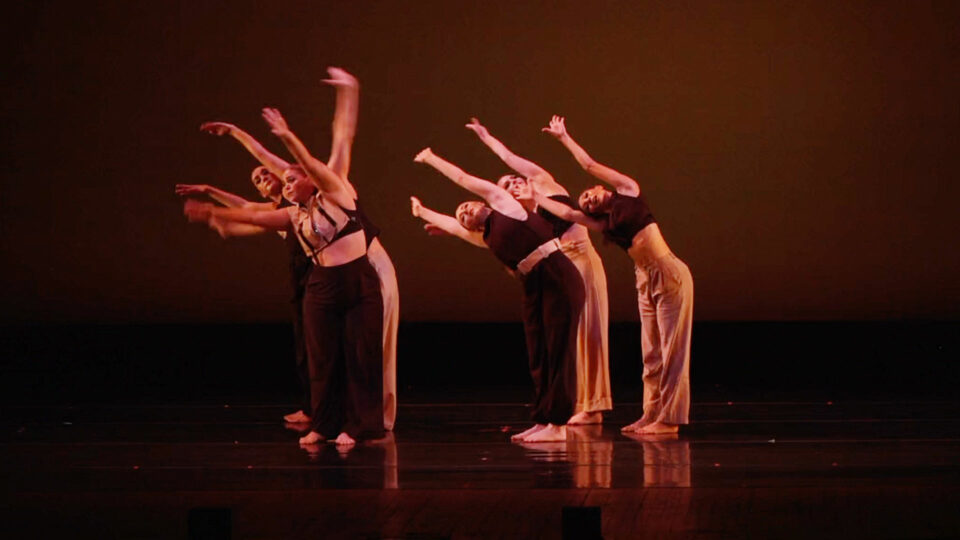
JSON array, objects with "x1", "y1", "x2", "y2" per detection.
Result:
[{"x1": 466, "y1": 118, "x2": 613, "y2": 425}]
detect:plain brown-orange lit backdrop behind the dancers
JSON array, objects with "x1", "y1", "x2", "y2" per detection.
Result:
[{"x1": 0, "y1": 0, "x2": 960, "y2": 323}]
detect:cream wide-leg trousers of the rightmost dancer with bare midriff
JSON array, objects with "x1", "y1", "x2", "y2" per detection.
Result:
[{"x1": 636, "y1": 253, "x2": 693, "y2": 424}]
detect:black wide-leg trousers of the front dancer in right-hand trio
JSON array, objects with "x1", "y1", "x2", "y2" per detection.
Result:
[{"x1": 523, "y1": 251, "x2": 584, "y2": 425}]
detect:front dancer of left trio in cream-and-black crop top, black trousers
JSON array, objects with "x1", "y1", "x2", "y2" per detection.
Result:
[{"x1": 184, "y1": 109, "x2": 383, "y2": 446}]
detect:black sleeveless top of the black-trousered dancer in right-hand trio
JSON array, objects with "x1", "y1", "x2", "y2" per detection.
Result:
[{"x1": 483, "y1": 210, "x2": 554, "y2": 270}]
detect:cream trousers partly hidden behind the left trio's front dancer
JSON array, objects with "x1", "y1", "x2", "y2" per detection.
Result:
[{"x1": 367, "y1": 239, "x2": 400, "y2": 431}]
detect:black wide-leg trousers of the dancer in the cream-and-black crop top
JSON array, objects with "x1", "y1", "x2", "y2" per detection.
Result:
[{"x1": 303, "y1": 256, "x2": 383, "y2": 439}]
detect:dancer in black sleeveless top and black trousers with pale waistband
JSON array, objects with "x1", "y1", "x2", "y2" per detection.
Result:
[{"x1": 411, "y1": 148, "x2": 584, "y2": 442}]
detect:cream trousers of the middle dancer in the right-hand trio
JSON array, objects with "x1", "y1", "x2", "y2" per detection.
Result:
[{"x1": 564, "y1": 240, "x2": 613, "y2": 413}]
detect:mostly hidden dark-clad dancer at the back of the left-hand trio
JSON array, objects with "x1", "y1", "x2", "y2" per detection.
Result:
[{"x1": 175, "y1": 167, "x2": 311, "y2": 424}]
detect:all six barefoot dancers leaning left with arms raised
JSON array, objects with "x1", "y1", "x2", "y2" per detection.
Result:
[{"x1": 176, "y1": 68, "x2": 693, "y2": 446}]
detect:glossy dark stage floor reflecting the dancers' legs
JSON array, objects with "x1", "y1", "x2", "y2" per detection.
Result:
[{"x1": 0, "y1": 401, "x2": 960, "y2": 539}]
